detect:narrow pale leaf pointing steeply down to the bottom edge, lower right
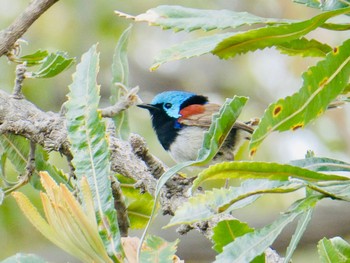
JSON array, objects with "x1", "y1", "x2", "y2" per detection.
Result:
[{"x1": 283, "y1": 208, "x2": 313, "y2": 263}]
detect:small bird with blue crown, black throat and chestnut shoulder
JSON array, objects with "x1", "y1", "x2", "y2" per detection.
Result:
[{"x1": 137, "y1": 90, "x2": 256, "y2": 163}]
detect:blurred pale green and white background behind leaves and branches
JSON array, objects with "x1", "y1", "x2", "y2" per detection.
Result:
[{"x1": 0, "y1": 0, "x2": 350, "y2": 262}]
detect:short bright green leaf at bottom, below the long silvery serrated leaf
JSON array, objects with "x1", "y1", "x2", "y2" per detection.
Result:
[{"x1": 211, "y1": 219, "x2": 254, "y2": 253}]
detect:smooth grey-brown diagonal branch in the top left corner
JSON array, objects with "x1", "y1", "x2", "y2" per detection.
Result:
[{"x1": 0, "y1": 0, "x2": 58, "y2": 57}]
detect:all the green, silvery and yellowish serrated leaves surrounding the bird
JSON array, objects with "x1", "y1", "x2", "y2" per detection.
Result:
[{"x1": 0, "y1": 0, "x2": 350, "y2": 262}]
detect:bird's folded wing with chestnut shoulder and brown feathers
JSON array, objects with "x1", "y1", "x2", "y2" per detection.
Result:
[{"x1": 178, "y1": 103, "x2": 257, "y2": 133}]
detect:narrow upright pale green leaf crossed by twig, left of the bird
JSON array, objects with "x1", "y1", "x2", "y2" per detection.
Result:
[{"x1": 110, "y1": 25, "x2": 132, "y2": 140}]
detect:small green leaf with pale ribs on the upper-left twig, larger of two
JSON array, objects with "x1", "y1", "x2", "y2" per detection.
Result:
[{"x1": 29, "y1": 51, "x2": 75, "y2": 78}]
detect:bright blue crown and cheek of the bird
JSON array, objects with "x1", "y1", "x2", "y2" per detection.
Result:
[{"x1": 151, "y1": 91, "x2": 196, "y2": 118}]
